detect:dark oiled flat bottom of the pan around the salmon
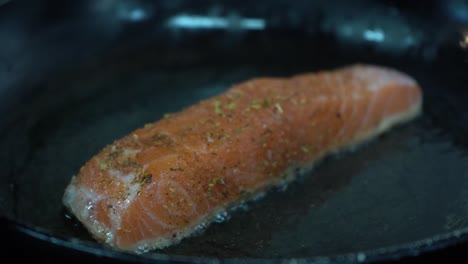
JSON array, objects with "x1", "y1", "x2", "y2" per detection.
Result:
[{"x1": 0, "y1": 35, "x2": 468, "y2": 258}]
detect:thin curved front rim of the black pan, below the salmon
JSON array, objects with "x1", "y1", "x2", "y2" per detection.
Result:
[{"x1": 5, "y1": 216, "x2": 468, "y2": 263}]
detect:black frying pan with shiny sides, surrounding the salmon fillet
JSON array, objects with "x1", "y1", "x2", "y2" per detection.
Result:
[{"x1": 0, "y1": 0, "x2": 468, "y2": 263}]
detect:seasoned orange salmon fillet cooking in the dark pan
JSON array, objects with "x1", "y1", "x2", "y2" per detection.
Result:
[{"x1": 63, "y1": 64, "x2": 422, "y2": 253}]
